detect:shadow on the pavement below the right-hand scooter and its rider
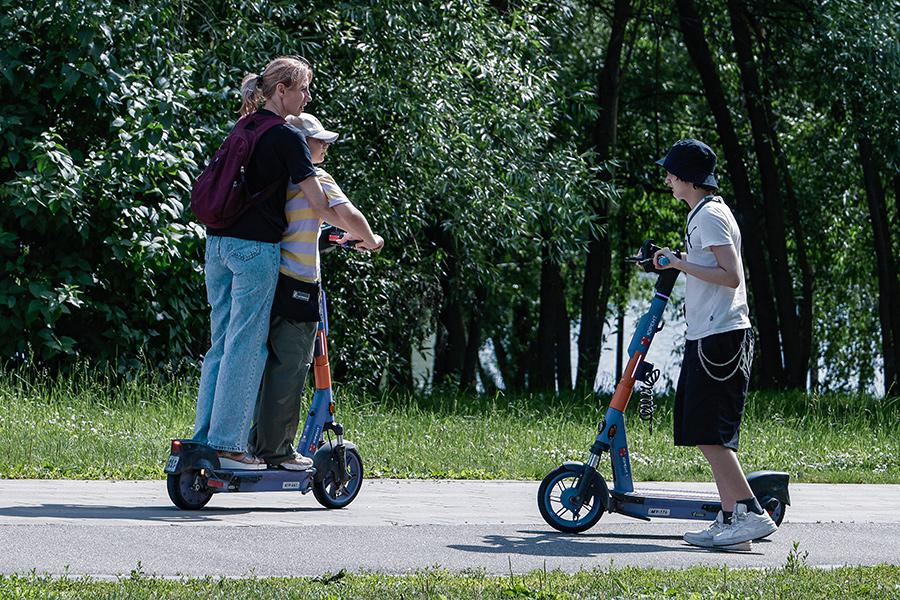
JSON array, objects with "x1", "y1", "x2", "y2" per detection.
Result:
[{"x1": 447, "y1": 531, "x2": 762, "y2": 558}]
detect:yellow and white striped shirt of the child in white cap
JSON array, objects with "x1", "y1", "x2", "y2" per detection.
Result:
[{"x1": 280, "y1": 167, "x2": 350, "y2": 283}]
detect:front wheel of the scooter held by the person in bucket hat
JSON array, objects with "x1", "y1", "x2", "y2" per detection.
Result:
[{"x1": 538, "y1": 465, "x2": 604, "y2": 533}]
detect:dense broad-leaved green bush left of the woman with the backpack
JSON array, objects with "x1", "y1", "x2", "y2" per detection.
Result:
[{"x1": 0, "y1": 1, "x2": 205, "y2": 369}]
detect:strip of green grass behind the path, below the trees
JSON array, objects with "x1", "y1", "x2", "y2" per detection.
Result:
[{"x1": 0, "y1": 371, "x2": 900, "y2": 483}]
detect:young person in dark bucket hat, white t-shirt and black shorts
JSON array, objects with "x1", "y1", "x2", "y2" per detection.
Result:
[{"x1": 654, "y1": 139, "x2": 777, "y2": 547}]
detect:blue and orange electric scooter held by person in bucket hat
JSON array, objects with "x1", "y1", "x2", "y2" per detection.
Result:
[{"x1": 537, "y1": 240, "x2": 791, "y2": 533}]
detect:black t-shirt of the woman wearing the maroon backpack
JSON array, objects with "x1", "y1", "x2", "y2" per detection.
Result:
[{"x1": 206, "y1": 108, "x2": 316, "y2": 243}]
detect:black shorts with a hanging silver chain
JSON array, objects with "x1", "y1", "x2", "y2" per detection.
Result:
[{"x1": 674, "y1": 329, "x2": 752, "y2": 451}]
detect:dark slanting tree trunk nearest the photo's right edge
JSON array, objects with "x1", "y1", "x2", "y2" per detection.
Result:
[{"x1": 859, "y1": 135, "x2": 900, "y2": 395}]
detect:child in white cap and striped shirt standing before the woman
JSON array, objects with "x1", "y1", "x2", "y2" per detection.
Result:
[{"x1": 250, "y1": 113, "x2": 384, "y2": 470}]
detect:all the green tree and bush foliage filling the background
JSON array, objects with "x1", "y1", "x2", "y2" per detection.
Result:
[{"x1": 0, "y1": 0, "x2": 900, "y2": 391}]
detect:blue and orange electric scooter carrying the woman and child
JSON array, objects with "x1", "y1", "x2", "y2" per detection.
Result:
[{"x1": 164, "y1": 228, "x2": 363, "y2": 510}]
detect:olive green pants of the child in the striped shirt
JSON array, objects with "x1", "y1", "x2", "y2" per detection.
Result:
[{"x1": 250, "y1": 315, "x2": 319, "y2": 465}]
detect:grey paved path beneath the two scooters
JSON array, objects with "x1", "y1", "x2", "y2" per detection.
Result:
[{"x1": 0, "y1": 480, "x2": 900, "y2": 577}]
